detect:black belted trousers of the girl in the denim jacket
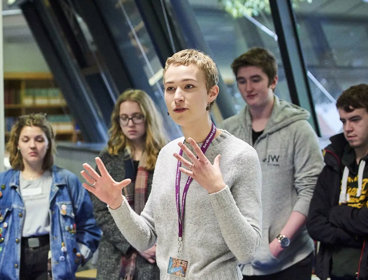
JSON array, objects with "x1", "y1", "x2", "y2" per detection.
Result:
[{"x1": 20, "y1": 238, "x2": 50, "y2": 280}]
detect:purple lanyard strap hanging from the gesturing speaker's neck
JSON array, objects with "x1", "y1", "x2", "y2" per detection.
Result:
[{"x1": 175, "y1": 123, "x2": 216, "y2": 240}]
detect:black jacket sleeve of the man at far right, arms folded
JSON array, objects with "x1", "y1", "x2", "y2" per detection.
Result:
[{"x1": 307, "y1": 166, "x2": 355, "y2": 246}]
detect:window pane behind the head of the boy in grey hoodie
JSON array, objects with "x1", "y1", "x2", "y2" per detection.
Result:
[{"x1": 189, "y1": 0, "x2": 290, "y2": 112}]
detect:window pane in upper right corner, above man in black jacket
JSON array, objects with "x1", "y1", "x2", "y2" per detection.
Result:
[{"x1": 293, "y1": 0, "x2": 368, "y2": 138}]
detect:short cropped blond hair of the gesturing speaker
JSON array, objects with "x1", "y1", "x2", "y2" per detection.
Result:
[{"x1": 163, "y1": 49, "x2": 219, "y2": 91}]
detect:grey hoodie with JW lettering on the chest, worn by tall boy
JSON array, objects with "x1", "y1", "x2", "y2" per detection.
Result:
[{"x1": 222, "y1": 96, "x2": 323, "y2": 275}]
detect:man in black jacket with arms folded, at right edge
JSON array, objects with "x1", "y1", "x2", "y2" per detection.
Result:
[{"x1": 307, "y1": 84, "x2": 368, "y2": 280}]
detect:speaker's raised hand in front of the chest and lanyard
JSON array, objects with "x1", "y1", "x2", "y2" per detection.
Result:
[{"x1": 174, "y1": 137, "x2": 226, "y2": 193}]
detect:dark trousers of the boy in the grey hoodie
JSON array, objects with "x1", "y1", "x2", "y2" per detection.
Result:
[{"x1": 243, "y1": 254, "x2": 313, "y2": 280}]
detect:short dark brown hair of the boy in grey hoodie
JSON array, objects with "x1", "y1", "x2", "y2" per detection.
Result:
[{"x1": 231, "y1": 47, "x2": 277, "y2": 84}]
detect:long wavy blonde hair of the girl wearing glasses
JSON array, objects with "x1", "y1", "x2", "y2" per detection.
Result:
[{"x1": 107, "y1": 89, "x2": 167, "y2": 170}]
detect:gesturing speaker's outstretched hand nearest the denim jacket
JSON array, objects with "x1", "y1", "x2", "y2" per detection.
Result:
[{"x1": 81, "y1": 157, "x2": 131, "y2": 209}]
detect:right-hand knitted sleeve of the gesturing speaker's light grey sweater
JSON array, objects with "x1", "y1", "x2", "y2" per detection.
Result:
[{"x1": 210, "y1": 148, "x2": 262, "y2": 263}]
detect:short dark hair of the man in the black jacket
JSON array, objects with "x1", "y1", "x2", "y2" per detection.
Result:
[{"x1": 336, "y1": 84, "x2": 368, "y2": 112}]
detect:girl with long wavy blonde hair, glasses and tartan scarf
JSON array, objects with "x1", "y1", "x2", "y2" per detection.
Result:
[{"x1": 91, "y1": 89, "x2": 166, "y2": 280}]
